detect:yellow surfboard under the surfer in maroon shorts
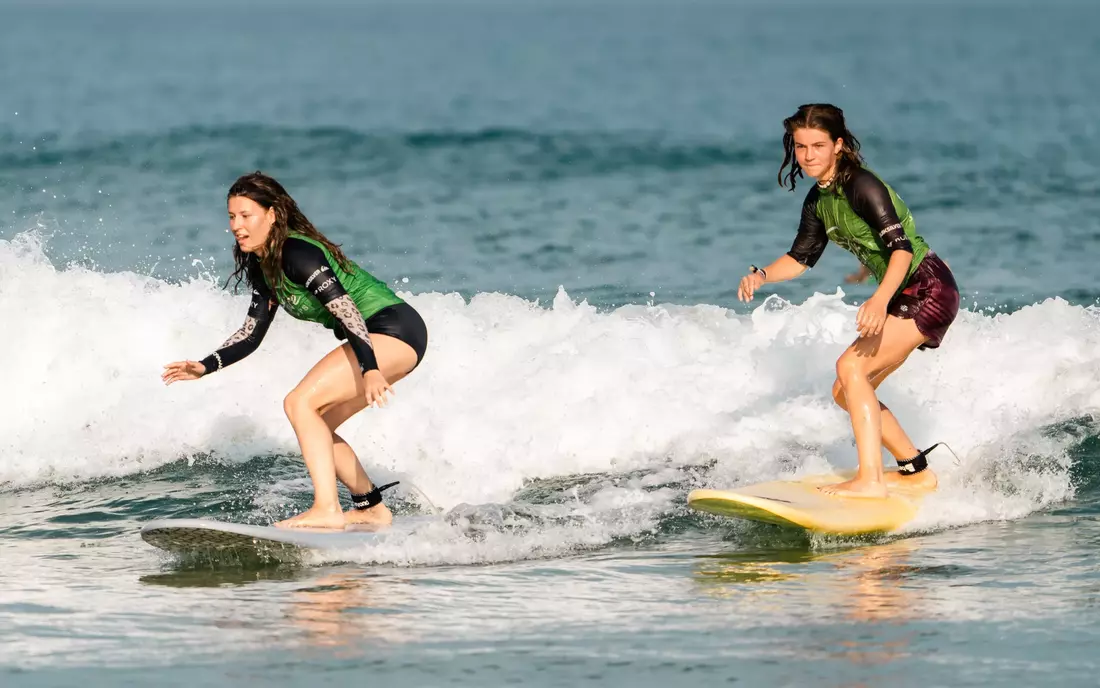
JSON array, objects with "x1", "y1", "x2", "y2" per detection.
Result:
[{"x1": 688, "y1": 469, "x2": 935, "y2": 535}]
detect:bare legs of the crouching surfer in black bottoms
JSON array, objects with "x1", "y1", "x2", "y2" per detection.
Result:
[{"x1": 275, "y1": 335, "x2": 416, "y2": 528}]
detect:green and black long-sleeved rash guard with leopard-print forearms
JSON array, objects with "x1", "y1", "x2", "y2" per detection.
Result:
[{"x1": 201, "y1": 236, "x2": 402, "y2": 373}]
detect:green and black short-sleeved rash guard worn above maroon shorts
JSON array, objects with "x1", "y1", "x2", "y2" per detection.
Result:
[{"x1": 788, "y1": 167, "x2": 928, "y2": 286}]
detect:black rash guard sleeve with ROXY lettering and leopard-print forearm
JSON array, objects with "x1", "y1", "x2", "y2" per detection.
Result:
[{"x1": 283, "y1": 237, "x2": 378, "y2": 373}]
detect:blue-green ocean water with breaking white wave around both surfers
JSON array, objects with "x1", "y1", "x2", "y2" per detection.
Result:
[{"x1": 0, "y1": 0, "x2": 1100, "y2": 687}]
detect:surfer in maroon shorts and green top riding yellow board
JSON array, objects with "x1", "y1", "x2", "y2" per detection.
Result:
[{"x1": 738, "y1": 105, "x2": 959, "y2": 498}]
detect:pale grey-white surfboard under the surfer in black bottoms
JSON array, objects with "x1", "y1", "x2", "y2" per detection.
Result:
[{"x1": 141, "y1": 516, "x2": 429, "y2": 557}]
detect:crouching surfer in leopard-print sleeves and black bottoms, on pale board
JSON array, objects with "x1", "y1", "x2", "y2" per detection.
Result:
[{"x1": 162, "y1": 172, "x2": 428, "y2": 528}]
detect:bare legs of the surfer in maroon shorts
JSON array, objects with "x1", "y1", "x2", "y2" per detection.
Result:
[{"x1": 821, "y1": 316, "x2": 925, "y2": 496}]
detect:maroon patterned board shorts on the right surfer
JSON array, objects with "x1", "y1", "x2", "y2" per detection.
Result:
[{"x1": 887, "y1": 252, "x2": 959, "y2": 349}]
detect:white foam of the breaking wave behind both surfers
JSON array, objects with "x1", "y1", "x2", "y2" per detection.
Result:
[{"x1": 0, "y1": 233, "x2": 1100, "y2": 559}]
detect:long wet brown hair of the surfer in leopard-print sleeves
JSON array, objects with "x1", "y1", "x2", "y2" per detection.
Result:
[{"x1": 226, "y1": 171, "x2": 351, "y2": 290}]
